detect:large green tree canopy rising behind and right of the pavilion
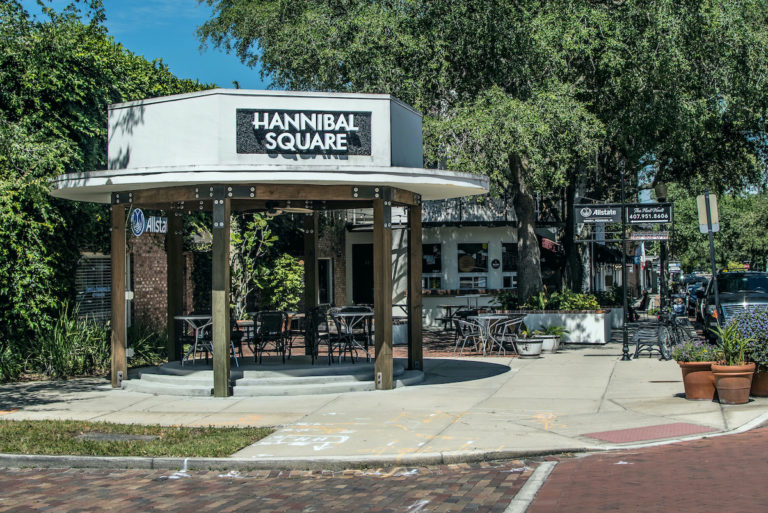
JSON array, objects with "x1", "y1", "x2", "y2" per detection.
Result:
[{"x1": 199, "y1": 0, "x2": 768, "y2": 294}]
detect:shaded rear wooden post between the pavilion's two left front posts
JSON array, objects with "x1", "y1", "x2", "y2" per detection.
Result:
[{"x1": 165, "y1": 208, "x2": 184, "y2": 362}]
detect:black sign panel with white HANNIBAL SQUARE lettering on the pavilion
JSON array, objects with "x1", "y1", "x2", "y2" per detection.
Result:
[{"x1": 236, "y1": 109, "x2": 371, "y2": 155}]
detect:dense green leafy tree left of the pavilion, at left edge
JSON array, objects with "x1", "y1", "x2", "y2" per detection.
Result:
[{"x1": 0, "y1": 0, "x2": 207, "y2": 380}]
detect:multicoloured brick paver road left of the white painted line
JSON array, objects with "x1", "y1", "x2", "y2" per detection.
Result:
[{"x1": 0, "y1": 461, "x2": 534, "y2": 513}]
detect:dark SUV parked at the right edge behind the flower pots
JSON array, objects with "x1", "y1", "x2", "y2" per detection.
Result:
[{"x1": 701, "y1": 271, "x2": 768, "y2": 339}]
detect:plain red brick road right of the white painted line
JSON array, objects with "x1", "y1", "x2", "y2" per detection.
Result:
[{"x1": 528, "y1": 428, "x2": 768, "y2": 513}]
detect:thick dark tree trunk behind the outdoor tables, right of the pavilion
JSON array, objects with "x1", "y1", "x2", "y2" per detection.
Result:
[{"x1": 510, "y1": 155, "x2": 544, "y2": 303}]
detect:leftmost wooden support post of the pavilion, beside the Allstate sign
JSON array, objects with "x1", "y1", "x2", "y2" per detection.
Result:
[{"x1": 111, "y1": 205, "x2": 128, "y2": 388}]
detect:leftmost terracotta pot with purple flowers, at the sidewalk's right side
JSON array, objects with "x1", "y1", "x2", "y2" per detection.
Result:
[{"x1": 672, "y1": 340, "x2": 716, "y2": 401}]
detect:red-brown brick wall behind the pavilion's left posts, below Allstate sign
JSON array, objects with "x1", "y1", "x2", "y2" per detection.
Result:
[{"x1": 128, "y1": 233, "x2": 193, "y2": 329}]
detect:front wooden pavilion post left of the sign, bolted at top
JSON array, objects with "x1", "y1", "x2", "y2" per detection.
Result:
[{"x1": 211, "y1": 195, "x2": 231, "y2": 397}]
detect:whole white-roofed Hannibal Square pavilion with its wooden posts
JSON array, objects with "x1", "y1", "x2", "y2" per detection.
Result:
[{"x1": 51, "y1": 89, "x2": 488, "y2": 397}]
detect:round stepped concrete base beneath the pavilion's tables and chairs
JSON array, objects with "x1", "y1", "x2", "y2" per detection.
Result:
[{"x1": 122, "y1": 356, "x2": 424, "y2": 397}]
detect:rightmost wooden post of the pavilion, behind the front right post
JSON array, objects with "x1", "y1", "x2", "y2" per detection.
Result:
[{"x1": 408, "y1": 205, "x2": 424, "y2": 370}]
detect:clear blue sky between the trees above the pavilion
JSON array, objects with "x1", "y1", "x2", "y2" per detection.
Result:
[{"x1": 21, "y1": 0, "x2": 269, "y2": 89}]
